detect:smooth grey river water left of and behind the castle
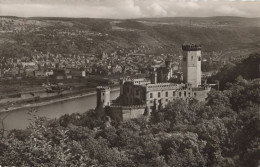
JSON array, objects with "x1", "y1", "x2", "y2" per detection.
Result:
[{"x1": 0, "y1": 90, "x2": 119, "y2": 130}]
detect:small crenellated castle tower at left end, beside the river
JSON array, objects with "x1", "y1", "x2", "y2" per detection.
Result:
[{"x1": 97, "y1": 86, "x2": 110, "y2": 107}]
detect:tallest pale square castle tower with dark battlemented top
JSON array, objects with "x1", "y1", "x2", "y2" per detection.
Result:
[{"x1": 182, "y1": 44, "x2": 201, "y2": 87}]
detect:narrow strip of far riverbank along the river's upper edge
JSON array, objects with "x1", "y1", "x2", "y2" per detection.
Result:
[{"x1": 0, "y1": 86, "x2": 119, "y2": 112}]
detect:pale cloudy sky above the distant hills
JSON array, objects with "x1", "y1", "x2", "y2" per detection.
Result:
[{"x1": 0, "y1": 0, "x2": 260, "y2": 18}]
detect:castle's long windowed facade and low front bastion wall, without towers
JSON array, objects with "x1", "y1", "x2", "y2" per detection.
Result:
[{"x1": 107, "y1": 85, "x2": 210, "y2": 121}]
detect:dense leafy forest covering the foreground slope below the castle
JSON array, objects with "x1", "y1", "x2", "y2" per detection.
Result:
[{"x1": 0, "y1": 54, "x2": 260, "y2": 167}]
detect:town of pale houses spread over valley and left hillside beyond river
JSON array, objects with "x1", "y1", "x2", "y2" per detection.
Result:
[{"x1": 0, "y1": 17, "x2": 254, "y2": 83}]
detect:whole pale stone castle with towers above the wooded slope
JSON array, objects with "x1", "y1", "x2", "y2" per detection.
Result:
[{"x1": 97, "y1": 44, "x2": 211, "y2": 121}]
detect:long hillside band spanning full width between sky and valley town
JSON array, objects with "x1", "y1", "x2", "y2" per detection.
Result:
[{"x1": 0, "y1": 17, "x2": 260, "y2": 56}]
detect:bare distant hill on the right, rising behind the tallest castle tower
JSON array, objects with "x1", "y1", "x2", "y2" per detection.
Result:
[{"x1": 111, "y1": 17, "x2": 260, "y2": 50}]
